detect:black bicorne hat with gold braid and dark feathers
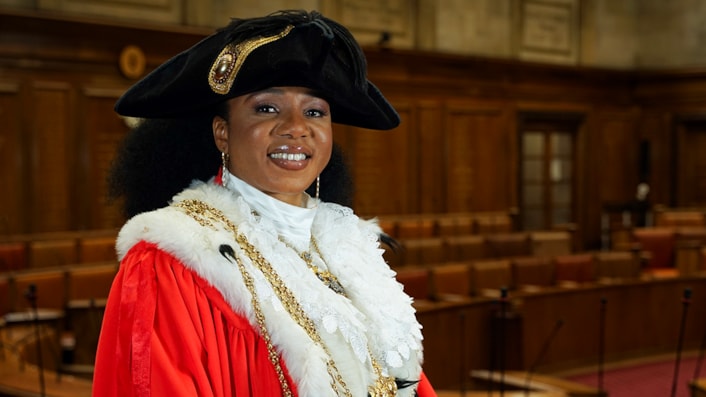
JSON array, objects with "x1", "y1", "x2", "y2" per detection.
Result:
[{"x1": 115, "y1": 11, "x2": 400, "y2": 130}]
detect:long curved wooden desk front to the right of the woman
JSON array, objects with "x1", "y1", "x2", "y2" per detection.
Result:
[{"x1": 417, "y1": 276, "x2": 706, "y2": 390}]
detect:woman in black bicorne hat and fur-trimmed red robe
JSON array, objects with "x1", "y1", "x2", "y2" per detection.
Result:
[{"x1": 93, "y1": 11, "x2": 435, "y2": 397}]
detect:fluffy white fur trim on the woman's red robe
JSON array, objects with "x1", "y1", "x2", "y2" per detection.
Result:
[{"x1": 117, "y1": 183, "x2": 422, "y2": 397}]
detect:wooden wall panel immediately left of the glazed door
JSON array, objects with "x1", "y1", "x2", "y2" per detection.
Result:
[{"x1": 444, "y1": 102, "x2": 517, "y2": 212}]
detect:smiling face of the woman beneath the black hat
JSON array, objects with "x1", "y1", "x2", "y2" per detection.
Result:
[{"x1": 213, "y1": 87, "x2": 333, "y2": 206}]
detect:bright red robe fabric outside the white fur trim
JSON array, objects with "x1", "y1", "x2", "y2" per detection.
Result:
[{"x1": 93, "y1": 242, "x2": 436, "y2": 397}]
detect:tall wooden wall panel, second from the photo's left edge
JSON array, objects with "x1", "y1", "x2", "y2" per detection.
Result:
[{"x1": 25, "y1": 81, "x2": 78, "y2": 232}]
